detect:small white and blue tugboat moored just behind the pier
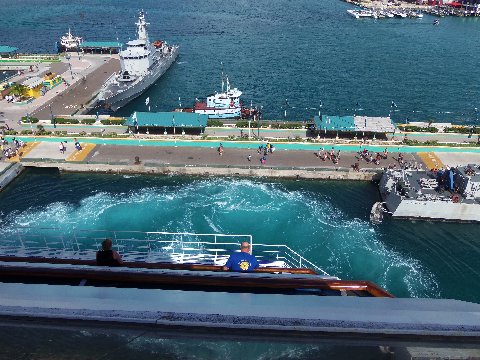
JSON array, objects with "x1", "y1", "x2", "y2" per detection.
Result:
[{"x1": 193, "y1": 73, "x2": 258, "y2": 119}]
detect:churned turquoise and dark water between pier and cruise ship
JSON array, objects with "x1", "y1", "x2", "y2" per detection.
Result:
[{"x1": 0, "y1": 170, "x2": 480, "y2": 302}]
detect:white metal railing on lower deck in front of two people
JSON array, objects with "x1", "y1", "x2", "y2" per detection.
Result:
[{"x1": 0, "y1": 227, "x2": 329, "y2": 276}]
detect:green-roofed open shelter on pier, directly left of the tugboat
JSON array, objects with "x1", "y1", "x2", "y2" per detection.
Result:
[{"x1": 125, "y1": 111, "x2": 208, "y2": 134}]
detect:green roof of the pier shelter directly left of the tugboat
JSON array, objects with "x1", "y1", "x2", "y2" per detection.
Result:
[{"x1": 126, "y1": 111, "x2": 208, "y2": 128}]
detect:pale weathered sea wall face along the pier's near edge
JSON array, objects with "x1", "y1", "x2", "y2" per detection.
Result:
[{"x1": 19, "y1": 162, "x2": 381, "y2": 181}]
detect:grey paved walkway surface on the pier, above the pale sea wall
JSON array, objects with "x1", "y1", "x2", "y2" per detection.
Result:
[{"x1": 14, "y1": 140, "x2": 421, "y2": 169}]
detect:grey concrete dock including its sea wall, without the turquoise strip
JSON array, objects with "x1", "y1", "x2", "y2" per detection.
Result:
[{"x1": 10, "y1": 139, "x2": 421, "y2": 180}]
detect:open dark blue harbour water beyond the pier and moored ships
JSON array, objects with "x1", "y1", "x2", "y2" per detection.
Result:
[{"x1": 0, "y1": 0, "x2": 480, "y2": 123}]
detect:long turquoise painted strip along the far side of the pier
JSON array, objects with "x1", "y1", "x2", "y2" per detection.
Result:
[{"x1": 7, "y1": 136, "x2": 480, "y2": 153}]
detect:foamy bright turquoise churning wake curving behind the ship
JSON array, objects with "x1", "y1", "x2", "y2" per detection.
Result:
[{"x1": 1, "y1": 178, "x2": 440, "y2": 297}]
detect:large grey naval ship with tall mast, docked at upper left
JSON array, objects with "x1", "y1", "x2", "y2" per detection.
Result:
[{"x1": 98, "y1": 11, "x2": 178, "y2": 111}]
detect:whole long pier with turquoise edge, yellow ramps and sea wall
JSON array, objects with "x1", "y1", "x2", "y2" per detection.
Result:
[{"x1": 1, "y1": 138, "x2": 480, "y2": 181}]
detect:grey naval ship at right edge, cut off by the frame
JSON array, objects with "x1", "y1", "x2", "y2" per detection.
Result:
[{"x1": 371, "y1": 165, "x2": 480, "y2": 222}]
